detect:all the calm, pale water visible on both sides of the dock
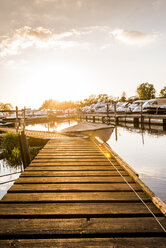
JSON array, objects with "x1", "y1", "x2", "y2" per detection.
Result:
[{"x1": 0, "y1": 121, "x2": 166, "y2": 203}]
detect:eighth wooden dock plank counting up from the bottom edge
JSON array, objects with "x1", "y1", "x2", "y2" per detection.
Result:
[{"x1": 25, "y1": 165, "x2": 123, "y2": 171}]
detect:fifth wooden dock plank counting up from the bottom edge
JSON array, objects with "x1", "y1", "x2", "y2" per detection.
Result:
[{"x1": 8, "y1": 183, "x2": 142, "y2": 193}]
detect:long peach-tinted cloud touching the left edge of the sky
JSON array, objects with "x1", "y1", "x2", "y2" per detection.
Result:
[{"x1": 0, "y1": 26, "x2": 78, "y2": 57}]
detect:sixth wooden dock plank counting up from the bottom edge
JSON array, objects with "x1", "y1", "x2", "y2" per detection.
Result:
[{"x1": 15, "y1": 176, "x2": 134, "y2": 184}]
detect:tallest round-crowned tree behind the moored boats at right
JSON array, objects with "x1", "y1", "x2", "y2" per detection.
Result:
[{"x1": 137, "y1": 83, "x2": 156, "y2": 100}]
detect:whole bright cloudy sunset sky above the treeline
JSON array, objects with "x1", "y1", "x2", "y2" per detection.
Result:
[{"x1": 0, "y1": 0, "x2": 166, "y2": 108}]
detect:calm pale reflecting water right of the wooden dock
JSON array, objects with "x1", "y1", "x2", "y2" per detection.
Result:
[{"x1": 107, "y1": 126, "x2": 166, "y2": 203}]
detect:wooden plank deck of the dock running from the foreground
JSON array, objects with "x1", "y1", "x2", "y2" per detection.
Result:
[{"x1": 0, "y1": 137, "x2": 166, "y2": 248}]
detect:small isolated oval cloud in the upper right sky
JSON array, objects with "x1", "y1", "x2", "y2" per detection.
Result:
[{"x1": 111, "y1": 29, "x2": 156, "y2": 45}]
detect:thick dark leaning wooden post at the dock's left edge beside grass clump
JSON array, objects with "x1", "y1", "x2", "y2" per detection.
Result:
[{"x1": 19, "y1": 131, "x2": 31, "y2": 169}]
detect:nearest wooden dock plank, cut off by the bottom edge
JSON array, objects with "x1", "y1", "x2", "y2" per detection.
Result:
[{"x1": 0, "y1": 237, "x2": 166, "y2": 248}]
